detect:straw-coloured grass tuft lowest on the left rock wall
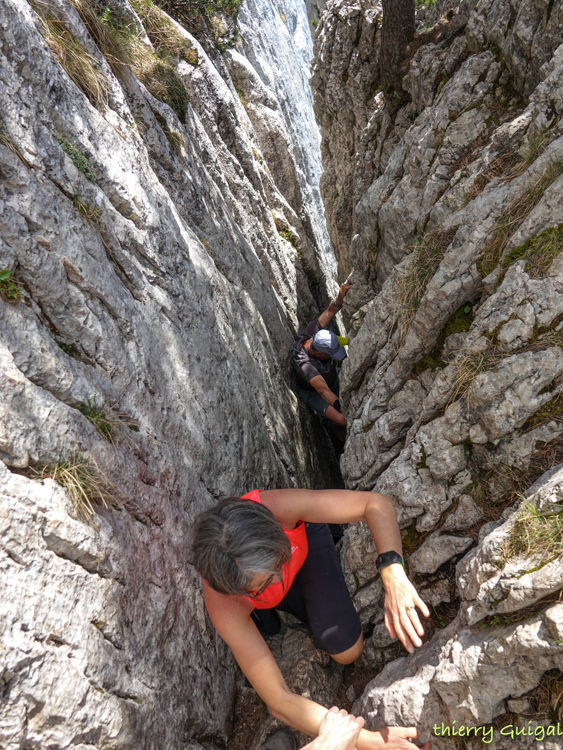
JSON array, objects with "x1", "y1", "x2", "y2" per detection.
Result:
[{"x1": 38, "y1": 455, "x2": 116, "y2": 522}]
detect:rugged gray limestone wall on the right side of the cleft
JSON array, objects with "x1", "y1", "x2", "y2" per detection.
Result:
[{"x1": 312, "y1": 0, "x2": 563, "y2": 748}]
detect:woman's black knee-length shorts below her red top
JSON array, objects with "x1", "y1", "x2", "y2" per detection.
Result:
[{"x1": 255, "y1": 523, "x2": 362, "y2": 654}]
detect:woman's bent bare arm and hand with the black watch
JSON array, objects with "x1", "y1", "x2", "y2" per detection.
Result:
[{"x1": 260, "y1": 489, "x2": 430, "y2": 653}]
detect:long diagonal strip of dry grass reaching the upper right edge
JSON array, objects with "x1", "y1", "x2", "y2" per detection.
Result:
[{"x1": 477, "y1": 161, "x2": 563, "y2": 277}]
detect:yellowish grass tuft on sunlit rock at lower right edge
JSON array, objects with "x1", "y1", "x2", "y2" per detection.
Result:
[{"x1": 501, "y1": 502, "x2": 563, "y2": 563}]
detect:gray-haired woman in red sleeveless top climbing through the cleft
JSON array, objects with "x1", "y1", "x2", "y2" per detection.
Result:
[{"x1": 193, "y1": 489, "x2": 429, "y2": 750}]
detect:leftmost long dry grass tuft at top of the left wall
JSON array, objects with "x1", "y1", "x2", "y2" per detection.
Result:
[{"x1": 31, "y1": 0, "x2": 109, "y2": 110}]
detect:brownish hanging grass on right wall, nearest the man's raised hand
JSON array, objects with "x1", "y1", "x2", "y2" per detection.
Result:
[{"x1": 397, "y1": 228, "x2": 457, "y2": 346}]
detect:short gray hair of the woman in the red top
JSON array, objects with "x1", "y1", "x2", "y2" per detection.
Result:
[{"x1": 193, "y1": 498, "x2": 291, "y2": 594}]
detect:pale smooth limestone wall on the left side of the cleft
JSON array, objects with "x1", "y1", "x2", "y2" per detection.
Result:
[{"x1": 0, "y1": 0, "x2": 340, "y2": 750}]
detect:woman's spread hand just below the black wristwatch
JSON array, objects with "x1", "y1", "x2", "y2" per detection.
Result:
[{"x1": 381, "y1": 563, "x2": 430, "y2": 654}]
